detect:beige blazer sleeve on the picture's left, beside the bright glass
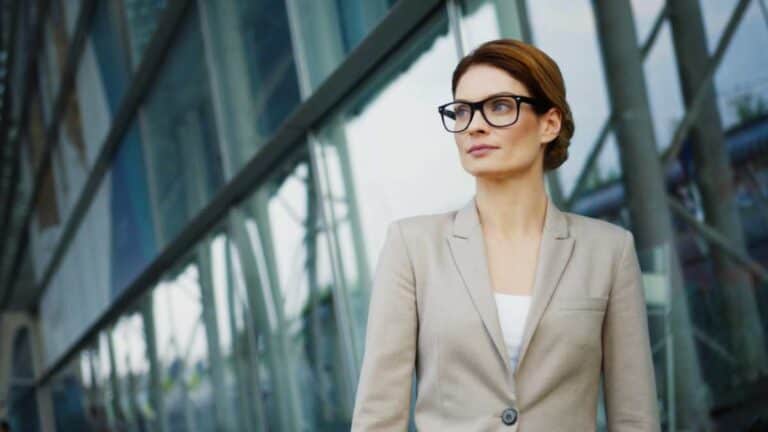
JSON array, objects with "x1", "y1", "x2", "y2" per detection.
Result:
[{"x1": 352, "y1": 221, "x2": 418, "y2": 432}]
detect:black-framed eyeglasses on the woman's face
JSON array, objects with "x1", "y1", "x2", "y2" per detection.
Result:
[{"x1": 437, "y1": 93, "x2": 541, "y2": 133}]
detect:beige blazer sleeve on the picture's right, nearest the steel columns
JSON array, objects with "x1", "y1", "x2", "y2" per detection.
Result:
[{"x1": 603, "y1": 230, "x2": 661, "y2": 432}]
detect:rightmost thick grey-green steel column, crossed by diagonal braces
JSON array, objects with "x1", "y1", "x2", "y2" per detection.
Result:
[{"x1": 667, "y1": 0, "x2": 768, "y2": 380}]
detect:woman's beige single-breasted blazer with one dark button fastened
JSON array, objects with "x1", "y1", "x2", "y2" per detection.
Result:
[{"x1": 352, "y1": 197, "x2": 660, "y2": 432}]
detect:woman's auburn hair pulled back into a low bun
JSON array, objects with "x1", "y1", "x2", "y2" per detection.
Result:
[{"x1": 451, "y1": 39, "x2": 576, "y2": 171}]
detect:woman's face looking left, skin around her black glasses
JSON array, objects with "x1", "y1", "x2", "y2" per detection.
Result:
[{"x1": 454, "y1": 64, "x2": 560, "y2": 179}]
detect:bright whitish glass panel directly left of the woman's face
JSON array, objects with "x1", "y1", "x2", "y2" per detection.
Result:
[{"x1": 308, "y1": 10, "x2": 460, "y2": 361}]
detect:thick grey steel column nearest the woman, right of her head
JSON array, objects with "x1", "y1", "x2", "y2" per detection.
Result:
[{"x1": 593, "y1": 0, "x2": 711, "y2": 430}]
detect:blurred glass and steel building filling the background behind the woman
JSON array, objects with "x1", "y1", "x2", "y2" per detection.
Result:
[{"x1": 0, "y1": 0, "x2": 768, "y2": 432}]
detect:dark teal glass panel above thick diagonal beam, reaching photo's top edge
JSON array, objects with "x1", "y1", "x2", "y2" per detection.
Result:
[{"x1": 198, "y1": 0, "x2": 300, "y2": 176}]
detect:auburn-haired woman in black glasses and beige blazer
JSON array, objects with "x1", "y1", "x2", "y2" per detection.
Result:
[{"x1": 352, "y1": 39, "x2": 659, "y2": 432}]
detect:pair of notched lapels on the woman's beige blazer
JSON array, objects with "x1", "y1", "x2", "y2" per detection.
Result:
[{"x1": 448, "y1": 195, "x2": 574, "y2": 386}]
